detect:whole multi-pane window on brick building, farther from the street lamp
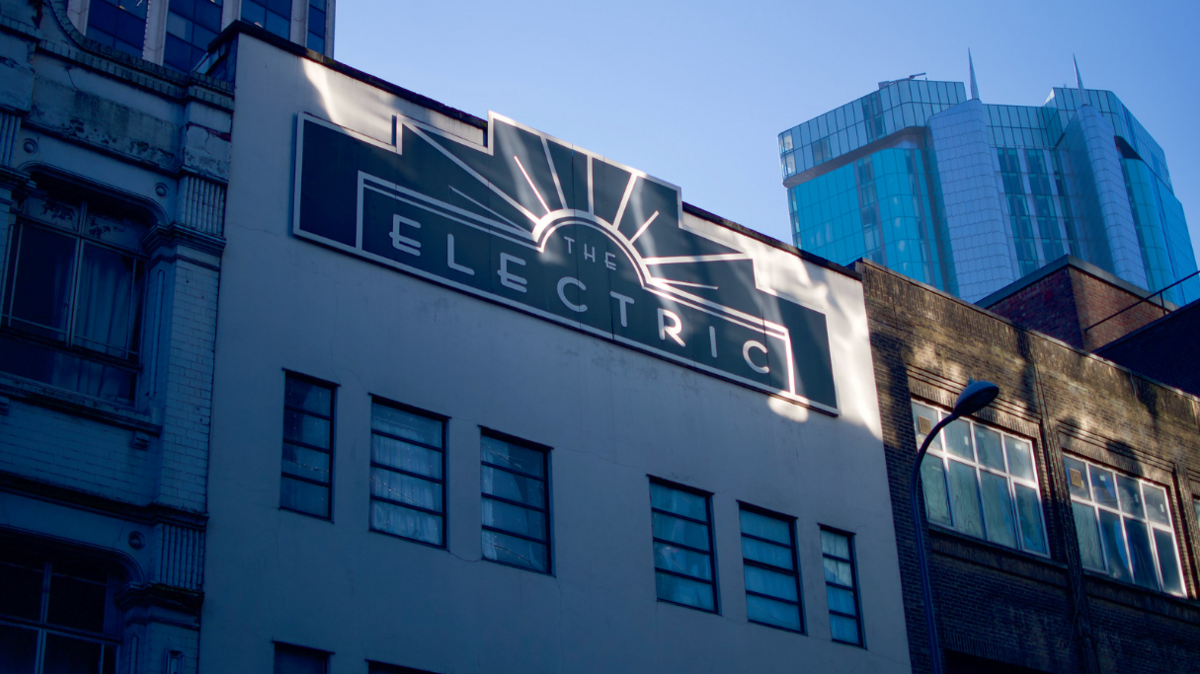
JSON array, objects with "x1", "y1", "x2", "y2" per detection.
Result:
[{"x1": 1063, "y1": 457, "x2": 1183, "y2": 595}]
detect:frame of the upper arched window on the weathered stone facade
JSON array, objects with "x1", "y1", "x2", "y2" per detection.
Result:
[{"x1": 0, "y1": 184, "x2": 155, "y2": 408}]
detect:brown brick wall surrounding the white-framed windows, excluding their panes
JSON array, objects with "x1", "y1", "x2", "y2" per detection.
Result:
[{"x1": 858, "y1": 257, "x2": 1200, "y2": 673}]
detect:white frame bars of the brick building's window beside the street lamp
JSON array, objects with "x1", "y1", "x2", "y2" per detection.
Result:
[{"x1": 910, "y1": 399, "x2": 1051, "y2": 559}]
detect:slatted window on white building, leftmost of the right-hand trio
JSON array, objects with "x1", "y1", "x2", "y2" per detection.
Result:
[{"x1": 650, "y1": 480, "x2": 716, "y2": 613}]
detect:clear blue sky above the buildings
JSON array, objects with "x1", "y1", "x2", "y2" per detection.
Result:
[{"x1": 335, "y1": 0, "x2": 1200, "y2": 267}]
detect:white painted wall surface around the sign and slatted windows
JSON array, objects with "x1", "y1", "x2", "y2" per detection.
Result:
[{"x1": 200, "y1": 35, "x2": 908, "y2": 674}]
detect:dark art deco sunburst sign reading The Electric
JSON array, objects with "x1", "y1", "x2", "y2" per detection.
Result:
[{"x1": 293, "y1": 114, "x2": 838, "y2": 413}]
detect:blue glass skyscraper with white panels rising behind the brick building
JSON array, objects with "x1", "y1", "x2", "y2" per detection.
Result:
[{"x1": 779, "y1": 66, "x2": 1200, "y2": 305}]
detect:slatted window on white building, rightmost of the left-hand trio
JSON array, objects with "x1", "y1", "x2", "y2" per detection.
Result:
[{"x1": 480, "y1": 433, "x2": 550, "y2": 573}]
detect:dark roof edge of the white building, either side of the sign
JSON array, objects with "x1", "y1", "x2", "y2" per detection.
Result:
[{"x1": 209, "y1": 19, "x2": 863, "y2": 281}]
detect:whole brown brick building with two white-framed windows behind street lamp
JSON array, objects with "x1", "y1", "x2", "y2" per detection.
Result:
[{"x1": 857, "y1": 261, "x2": 1200, "y2": 673}]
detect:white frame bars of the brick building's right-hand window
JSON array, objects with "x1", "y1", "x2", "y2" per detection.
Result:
[{"x1": 1062, "y1": 453, "x2": 1188, "y2": 598}]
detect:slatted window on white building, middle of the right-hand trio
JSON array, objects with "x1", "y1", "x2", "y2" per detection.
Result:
[{"x1": 740, "y1": 504, "x2": 804, "y2": 632}]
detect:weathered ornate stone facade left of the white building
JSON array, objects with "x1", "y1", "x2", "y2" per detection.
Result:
[{"x1": 0, "y1": 0, "x2": 233, "y2": 674}]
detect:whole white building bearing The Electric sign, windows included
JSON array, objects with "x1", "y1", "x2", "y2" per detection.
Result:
[{"x1": 199, "y1": 26, "x2": 910, "y2": 674}]
